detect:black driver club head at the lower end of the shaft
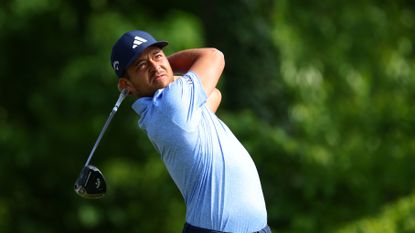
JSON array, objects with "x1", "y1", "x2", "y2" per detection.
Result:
[{"x1": 75, "y1": 165, "x2": 107, "y2": 198}]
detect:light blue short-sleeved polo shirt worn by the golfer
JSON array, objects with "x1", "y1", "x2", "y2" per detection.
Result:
[{"x1": 132, "y1": 72, "x2": 267, "y2": 233}]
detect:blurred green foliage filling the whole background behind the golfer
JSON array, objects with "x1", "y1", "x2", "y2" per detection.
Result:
[{"x1": 0, "y1": 0, "x2": 415, "y2": 233}]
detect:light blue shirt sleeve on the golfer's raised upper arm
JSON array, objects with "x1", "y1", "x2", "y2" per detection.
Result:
[{"x1": 160, "y1": 71, "x2": 207, "y2": 129}]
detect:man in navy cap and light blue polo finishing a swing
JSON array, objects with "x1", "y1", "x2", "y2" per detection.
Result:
[{"x1": 111, "y1": 30, "x2": 271, "y2": 233}]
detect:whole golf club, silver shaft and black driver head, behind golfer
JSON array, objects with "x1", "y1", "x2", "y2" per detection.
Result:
[{"x1": 75, "y1": 89, "x2": 128, "y2": 198}]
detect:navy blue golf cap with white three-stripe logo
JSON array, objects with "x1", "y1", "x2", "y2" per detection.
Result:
[{"x1": 111, "y1": 30, "x2": 168, "y2": 77}]
